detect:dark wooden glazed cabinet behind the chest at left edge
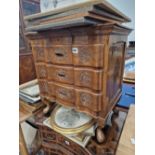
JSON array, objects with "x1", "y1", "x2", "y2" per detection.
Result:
[{"x1": 19, "y1": 0, "x2": 40, "y2": 84}]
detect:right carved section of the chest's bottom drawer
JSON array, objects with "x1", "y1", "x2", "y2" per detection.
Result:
[{"x1": 75, "y1": 89, "x2": 102, "y2": 112}]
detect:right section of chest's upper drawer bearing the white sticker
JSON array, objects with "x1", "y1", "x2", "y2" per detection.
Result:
[{"x1": 72, "y1": 45, "x2": 104, "y2": 67}]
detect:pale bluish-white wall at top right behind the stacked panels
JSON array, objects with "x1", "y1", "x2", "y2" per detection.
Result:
[{"x1": 107, "y1": 0, "x2": 135, "y2": 41}]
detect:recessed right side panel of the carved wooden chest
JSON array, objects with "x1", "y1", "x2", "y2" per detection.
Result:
[{"x1": 106, "y1": 35, "x2": 127, "y2": 110}]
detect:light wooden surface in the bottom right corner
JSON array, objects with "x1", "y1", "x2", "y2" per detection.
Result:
[{"x1": 116, "y1": 105, "x2": 135, "y2": 155}]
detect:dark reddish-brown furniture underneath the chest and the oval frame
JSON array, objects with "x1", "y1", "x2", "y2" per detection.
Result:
[{"x1": 31, "y1": 105, "x2": 127, "y2": 155}]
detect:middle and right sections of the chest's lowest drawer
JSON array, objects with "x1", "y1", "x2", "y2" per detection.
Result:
[{"x1": 48, "y1": 82, "x2": 102, "y2": 112}]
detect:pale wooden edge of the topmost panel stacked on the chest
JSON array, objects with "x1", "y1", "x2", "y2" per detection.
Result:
[{"x1": 24, "y1": 0, "x2": 131, "y2": 21}]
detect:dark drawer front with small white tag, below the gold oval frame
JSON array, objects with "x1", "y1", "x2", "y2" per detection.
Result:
[{"x1": 39, "y1": 126, "x2": 90, "y2": 155}]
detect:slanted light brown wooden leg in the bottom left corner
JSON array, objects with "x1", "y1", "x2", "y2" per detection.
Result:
[{"x1": 19, "y1": 124, "x2": 29, "y2": 155}]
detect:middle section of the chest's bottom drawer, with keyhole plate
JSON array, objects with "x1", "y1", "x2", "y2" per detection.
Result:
[{"x1": 55, "y1": 84, "x2": 75, "y2": 106}]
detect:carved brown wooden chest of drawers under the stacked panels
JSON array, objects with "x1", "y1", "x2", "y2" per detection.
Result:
[{"x1": 29, "y1": 24, "x2": 130, "y2": 142}]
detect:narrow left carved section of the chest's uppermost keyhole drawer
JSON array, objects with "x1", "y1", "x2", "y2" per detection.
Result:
[{"x1": 32, "y1": 46, "x2": 45, "y2": 62}]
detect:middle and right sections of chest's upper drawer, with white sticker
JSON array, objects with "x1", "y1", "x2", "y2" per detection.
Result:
[{"x1": 45, "y1": 44, "x2": 104, "y2": 67}]
